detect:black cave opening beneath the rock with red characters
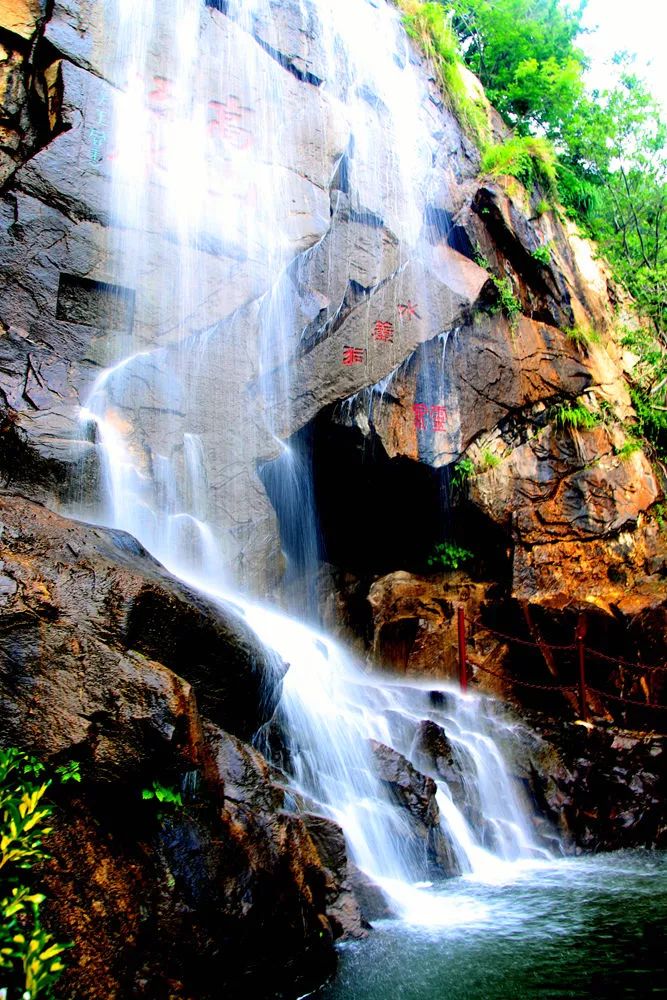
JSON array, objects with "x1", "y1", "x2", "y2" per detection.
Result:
[{"x1": 260, "y1": 407, "x2": 507, "y2": 576}]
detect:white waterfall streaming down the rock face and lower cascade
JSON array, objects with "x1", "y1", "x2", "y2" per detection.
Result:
[{"x1": 77, "y1": 0, "x2": 547, "y2": 923}]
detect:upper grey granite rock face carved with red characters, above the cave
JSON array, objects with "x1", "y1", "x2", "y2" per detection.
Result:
[{"x1": 0, "y1": 0, "x2": 660, "y2": 612}]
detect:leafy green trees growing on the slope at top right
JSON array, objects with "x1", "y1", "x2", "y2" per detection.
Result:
[{"x1": 442, "y1": 0, "x2": 667, "y2": 364}]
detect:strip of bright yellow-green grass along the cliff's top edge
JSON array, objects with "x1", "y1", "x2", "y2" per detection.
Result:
[{"x1": 396, "y1": 0, "x2": 490, "y2": 146}]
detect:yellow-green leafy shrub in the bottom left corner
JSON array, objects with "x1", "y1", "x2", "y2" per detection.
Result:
[{"x1": 0, "y1": 747, "x2": 71, "y2": 1000}]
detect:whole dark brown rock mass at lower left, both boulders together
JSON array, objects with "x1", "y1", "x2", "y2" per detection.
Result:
[{"x1": 0, "y1": 496, "x2": 364, "y2": 1000}]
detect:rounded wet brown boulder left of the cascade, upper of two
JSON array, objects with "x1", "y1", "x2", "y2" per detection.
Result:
[{"x1": 0, "y1": 496, "x2": 281, "y2": 764}]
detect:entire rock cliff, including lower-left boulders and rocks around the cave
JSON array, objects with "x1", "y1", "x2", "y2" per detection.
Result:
[{"x1": 0, "y1": 0, "x2": 667, "y2": 1000}]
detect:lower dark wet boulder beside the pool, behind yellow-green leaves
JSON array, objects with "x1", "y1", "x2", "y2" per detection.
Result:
[{"x1": 37, "y1": 724, "x2": 342, "y2": 1000}]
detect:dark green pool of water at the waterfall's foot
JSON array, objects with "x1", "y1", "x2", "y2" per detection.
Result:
[{"x1": 314, "y1": 852, "x2": 667, "y2": 1000}]
